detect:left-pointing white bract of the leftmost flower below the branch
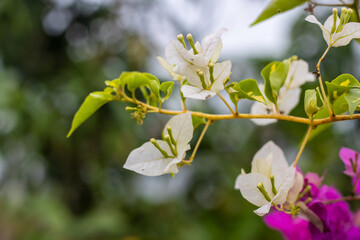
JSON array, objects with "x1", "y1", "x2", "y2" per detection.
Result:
[{"x1": 124, "y1": 140, "x2": 174, "y2": 176}]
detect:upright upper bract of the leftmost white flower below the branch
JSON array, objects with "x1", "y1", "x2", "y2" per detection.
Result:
[{"x1": 164, "y1": 112, "x2": 194, "y2": 150}]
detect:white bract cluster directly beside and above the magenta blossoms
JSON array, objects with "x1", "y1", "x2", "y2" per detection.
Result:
[{"x1": 235, "y1": 141, "x2": 303, "y2": 216}]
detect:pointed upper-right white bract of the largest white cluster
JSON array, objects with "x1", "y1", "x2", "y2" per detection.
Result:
[{"x1": 201, "y1": 28, "x2": 227, "y2": 63}]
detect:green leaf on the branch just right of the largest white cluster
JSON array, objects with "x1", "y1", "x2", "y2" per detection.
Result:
[{"x1": 229, "y1": 79, "x2": 266, "y2": 105}]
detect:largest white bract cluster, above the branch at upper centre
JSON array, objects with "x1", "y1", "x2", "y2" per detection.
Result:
[{"x1": 158, "y1": 28, "x2": 231, "y2": 100}]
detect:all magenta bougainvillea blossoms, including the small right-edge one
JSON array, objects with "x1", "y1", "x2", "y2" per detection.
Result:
[{"x1": 264, "y1": 148, "x2": 360, "y2": 240}]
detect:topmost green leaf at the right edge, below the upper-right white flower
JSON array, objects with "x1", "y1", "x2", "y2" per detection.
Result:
[{"x1": 326, "y1": 74, "x2": 360, "y2": 104}]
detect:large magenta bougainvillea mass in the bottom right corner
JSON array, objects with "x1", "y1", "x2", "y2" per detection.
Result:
[{"x1": 264, "y1": 174, "x2": 360, "y2": 240}]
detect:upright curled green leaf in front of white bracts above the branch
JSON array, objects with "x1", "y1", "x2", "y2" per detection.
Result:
[{"x1": 261, "y1": 59, "x2": 290, "y2": 104}]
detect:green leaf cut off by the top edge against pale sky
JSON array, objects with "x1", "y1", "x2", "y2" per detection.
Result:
[{"x1": 251, "y1": 0, "x2": 307, "y2": 26}]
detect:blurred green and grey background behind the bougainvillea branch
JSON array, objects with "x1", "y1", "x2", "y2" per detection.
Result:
[{"x1": 0, "y1": 0, "x2": 360, "y2": 240}]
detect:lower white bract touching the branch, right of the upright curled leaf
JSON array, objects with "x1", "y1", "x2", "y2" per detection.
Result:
[{"x1": 278, "y1": 88, "x2": 301, "y2": 115}]
